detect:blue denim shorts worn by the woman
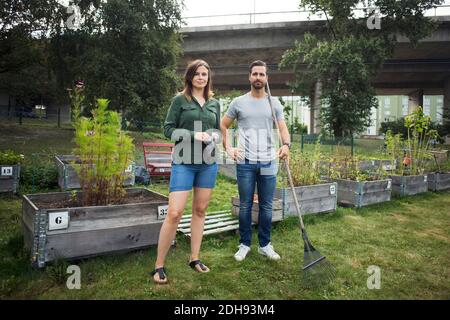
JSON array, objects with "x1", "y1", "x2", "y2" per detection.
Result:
[{"x1": 169, "y1": 162, "x2": 218, "y2": 192}]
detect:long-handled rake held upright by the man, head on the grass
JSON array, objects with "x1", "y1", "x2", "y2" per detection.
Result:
[{"x1": 266, "y1": 82, "x2": 336, "y2": 286}]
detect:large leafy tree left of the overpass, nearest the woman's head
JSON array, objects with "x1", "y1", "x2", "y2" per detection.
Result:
[{"x1": 52, "y1": 0, "x2": 185, "y2": 122}]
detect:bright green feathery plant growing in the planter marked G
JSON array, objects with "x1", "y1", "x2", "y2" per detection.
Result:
[{"x1": 74, "y1": 99, "x2": 134, "y2": 205}]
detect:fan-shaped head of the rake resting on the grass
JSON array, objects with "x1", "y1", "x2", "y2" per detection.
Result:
[{"x1": 302, "y1": 230, "x2": 336, "y2": 286}]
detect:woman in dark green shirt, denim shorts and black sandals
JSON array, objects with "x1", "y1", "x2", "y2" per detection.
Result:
[{"x1": 151, "y1": 60, "x2": 220, "y2": 284}]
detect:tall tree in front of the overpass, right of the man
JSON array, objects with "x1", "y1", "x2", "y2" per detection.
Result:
[{"x1": 281, "y1": 0, "x2": 443, "y2": 137}]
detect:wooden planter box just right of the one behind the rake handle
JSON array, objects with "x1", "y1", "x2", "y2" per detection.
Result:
[{"x1": 333, "y1": 179, "x2": 392, "y2": 208}]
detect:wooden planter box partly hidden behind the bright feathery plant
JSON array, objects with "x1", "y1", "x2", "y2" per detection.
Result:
[{"x1": 55, "y1": 155, "x2": 135, "y2": 191}]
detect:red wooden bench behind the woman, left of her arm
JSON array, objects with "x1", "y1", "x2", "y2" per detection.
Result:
[{"x1": 142, "y1": 142, "x2": 174, "y2": 177}]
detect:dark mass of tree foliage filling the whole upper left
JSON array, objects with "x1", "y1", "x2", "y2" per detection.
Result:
[{"x1": 0, "y1": 0, "x2": 181, "y2": 121}]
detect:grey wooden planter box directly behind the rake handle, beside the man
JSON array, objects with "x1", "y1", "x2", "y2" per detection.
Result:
[{"x1": 275, "y1": 182, "x2": 337, "y2": 217}]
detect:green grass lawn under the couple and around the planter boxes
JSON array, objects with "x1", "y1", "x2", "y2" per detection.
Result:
[{"x1": 0, "y1": 124, "x2": 450, "y2": 300}]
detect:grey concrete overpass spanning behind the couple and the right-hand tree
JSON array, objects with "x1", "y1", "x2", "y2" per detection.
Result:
[{"x1": 178, "y1": 16, "x2": 450, "y2": 131}]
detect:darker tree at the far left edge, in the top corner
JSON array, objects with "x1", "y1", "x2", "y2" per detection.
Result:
[{"x1": 0, "y1": 0, "x2": 64, "y2": 104}]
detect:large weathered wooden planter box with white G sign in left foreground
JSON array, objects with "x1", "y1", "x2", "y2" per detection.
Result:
[{"x1": 22, "y1": 188, "x2": 168, "y2": 268}]
